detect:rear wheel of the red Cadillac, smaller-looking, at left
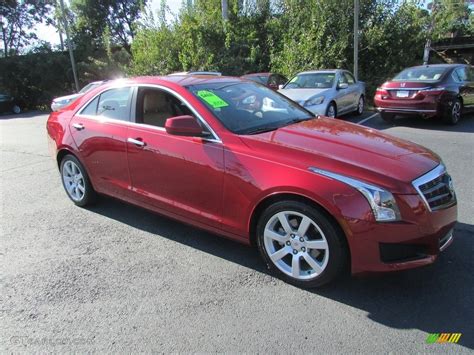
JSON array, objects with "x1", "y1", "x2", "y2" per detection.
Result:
[{"x1": 60, "y1": 154, "x2": 97, "y2": 207}]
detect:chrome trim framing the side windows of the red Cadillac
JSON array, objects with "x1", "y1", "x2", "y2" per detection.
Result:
[{"x1": 75, "y1": 83, "x2": 222, "y2": 144}]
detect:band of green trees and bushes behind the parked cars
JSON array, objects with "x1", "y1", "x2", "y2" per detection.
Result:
[{"x1": 4, "y1": 0, "x2": 474, "y2": 110}]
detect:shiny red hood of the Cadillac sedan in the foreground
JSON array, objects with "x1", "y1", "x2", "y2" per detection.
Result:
[{"x1": 241, "y1": 118, "x2": 441, "y2": 194}]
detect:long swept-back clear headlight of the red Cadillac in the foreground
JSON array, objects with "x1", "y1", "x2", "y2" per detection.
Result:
[{"x1": 309, "y1": 167, "x2": 400, "y2": 222}]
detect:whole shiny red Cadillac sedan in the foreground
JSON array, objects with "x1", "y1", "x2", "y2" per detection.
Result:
[{"x1": 47, "y1": 76, "x2": 457, "y2": 287}]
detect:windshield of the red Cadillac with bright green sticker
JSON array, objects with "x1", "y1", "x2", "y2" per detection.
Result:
[{"x1": 187, "y1": 82, "x2": 314, "y2": 134}]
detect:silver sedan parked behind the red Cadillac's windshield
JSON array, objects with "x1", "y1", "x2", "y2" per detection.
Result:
[{"x1": 278, "y1": 69, "x2": 365, "y2": 117}]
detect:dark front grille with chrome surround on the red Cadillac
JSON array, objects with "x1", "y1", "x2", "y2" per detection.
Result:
[{"x1": 413, "y1": 165, "x2": 456, "y2": 211}]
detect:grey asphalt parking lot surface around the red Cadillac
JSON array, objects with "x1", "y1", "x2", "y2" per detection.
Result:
[{"x1": 0, "y1": 112, "x2": 474, "y2": 353}]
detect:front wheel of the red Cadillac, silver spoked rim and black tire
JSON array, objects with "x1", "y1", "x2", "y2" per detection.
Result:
[{"x1": 257, "y1": 201, "x2": 347, "y2": 288}]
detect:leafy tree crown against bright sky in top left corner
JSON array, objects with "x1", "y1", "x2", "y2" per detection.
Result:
[{"x1": 0, "y1": 0, "x2": 51, "y2": 57}]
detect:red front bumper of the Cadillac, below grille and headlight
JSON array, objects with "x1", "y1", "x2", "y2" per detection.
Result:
[{"x1": 347, "y1": 195, "x2": 457, "y2": 274}]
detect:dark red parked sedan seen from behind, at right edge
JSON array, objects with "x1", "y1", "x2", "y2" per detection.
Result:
[{"x1": 374, "y1": 64, "x2": 474, "y2": 125}]
